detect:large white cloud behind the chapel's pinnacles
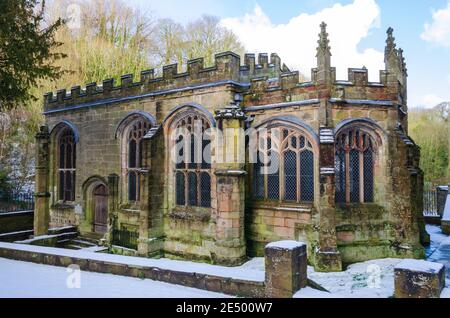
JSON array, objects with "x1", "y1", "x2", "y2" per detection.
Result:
[{"x1": 222, "y1": 0, "x2": 384, "y2": 81}]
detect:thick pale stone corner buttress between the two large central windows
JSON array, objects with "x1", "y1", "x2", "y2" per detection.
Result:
[{"x1": 214, "y1": 105, "x2": 246, "y2": 265}]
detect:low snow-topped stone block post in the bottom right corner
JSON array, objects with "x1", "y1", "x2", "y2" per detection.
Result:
[{"x1": 394, "y1": 260, "x2": 445, "y2": 298}]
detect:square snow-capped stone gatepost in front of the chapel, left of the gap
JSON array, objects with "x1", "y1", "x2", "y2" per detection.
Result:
[{"x1": 265, "y1": 241, "x2": 308, "y2": 298}]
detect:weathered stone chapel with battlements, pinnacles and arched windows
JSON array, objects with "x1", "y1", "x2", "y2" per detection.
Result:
[{"x1": 35, "y1": 24, "x2": 427, "y2": 271}]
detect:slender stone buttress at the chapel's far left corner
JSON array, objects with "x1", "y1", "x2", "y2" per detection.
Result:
[{"x1": 34, "y1": 126, "x2": 50, "y2": 236}]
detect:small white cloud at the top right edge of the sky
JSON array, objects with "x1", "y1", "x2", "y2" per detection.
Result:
[{"x1": 420, "y1": 1, "x2": 450, "y2": 47}]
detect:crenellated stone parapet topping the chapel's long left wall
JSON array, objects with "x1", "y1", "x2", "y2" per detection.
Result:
[{"x1": 44, "y1": 52, "x2": 289, "y2": 111}]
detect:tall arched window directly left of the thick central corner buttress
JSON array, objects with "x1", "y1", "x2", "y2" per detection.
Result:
[{"x1": 175, "y1": 113, "x2": 211, "y2": 208}]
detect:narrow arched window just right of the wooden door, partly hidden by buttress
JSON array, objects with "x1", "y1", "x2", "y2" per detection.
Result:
[{"x1": 125, "y1": 118, "x2": 150, "y2": 202}]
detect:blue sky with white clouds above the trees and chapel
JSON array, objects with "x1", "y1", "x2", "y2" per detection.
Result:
[{"x1": 128, "y1": 0, "x2": 450, "y2": 107}]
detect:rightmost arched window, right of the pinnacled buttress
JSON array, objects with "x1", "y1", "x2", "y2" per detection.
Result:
[{"x1": 335, "y1": 127, "x2": 376, "y2": 203}]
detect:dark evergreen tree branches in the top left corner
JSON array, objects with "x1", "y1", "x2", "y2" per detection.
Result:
[{"x1": 0, "y1": 0, "x2": 64, "y2": 110}]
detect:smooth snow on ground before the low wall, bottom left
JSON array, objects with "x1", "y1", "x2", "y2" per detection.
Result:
[{"x1": 0, "y1": 258, "x2": 229, "y2": 298}]
